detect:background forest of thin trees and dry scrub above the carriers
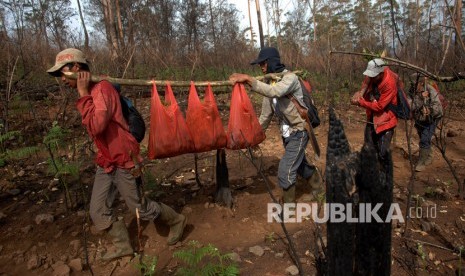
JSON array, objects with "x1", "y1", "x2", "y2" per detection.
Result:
[{"x1": 0, "y1": 0, "x2": 465, "y2": 90}]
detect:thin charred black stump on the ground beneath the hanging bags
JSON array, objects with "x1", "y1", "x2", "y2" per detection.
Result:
[{"x1": 215, "y1": 149, "x2": 233, "y2": 208}]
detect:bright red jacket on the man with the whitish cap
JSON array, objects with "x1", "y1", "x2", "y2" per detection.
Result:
[{"x1": 359, "y1": 67, "x2": 398, "y2": 133}]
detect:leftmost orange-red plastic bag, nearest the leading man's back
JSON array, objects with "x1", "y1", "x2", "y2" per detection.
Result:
[{"x1": 149, "y1": 84, "x2": 194, "y2": 159}]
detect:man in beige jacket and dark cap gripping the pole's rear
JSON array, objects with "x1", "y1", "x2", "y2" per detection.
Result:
[{"x1": 229, "y1": 47, "x2": 322, "y2": 203}]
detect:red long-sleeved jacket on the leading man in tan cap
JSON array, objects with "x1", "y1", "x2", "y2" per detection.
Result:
[{"x1": 76, "y1": 78, "x2": 142, "y2": 173}]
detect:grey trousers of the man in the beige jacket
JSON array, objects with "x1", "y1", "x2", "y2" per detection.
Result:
[{"x1": 278, "y1": 131, "x2": 316, "y2": 189}]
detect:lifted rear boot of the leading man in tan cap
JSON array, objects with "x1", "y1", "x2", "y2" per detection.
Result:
[{"x1": 156, "y1": 203, "x2": 187, "y2": 245}]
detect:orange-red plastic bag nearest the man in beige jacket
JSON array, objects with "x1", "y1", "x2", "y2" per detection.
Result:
[{"x1": 227, "y1": 83, "x2": 265, "y2": 149}]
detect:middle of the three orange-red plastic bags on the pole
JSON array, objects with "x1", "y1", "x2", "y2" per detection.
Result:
[{"x1": 186, "y1": 83, "x2": 227, "y2": 152}]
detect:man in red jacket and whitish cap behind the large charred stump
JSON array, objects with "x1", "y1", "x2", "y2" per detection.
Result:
[{"x1": 351, "y1": 58, "x2": 398, "y2": 168}]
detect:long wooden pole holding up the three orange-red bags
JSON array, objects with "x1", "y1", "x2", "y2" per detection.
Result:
[{"x1": 63, "y1": 71, "x2": 302, "y2": 87}]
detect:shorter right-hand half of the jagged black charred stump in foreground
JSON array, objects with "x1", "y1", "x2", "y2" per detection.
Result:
[{"x1": 354, "y1": 126, "x2": 393, "y2": 275}]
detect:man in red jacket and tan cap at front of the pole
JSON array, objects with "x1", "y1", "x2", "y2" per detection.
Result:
[{"x1": 47, "y1": 48, "x2": 187, "y2": 261}]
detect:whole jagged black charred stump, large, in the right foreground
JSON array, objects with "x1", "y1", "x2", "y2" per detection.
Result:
[{"x1": 319, "y1": 108, "x2": 393, "y2": 275}]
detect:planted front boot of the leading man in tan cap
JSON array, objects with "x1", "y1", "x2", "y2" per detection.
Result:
[{"x1": 102, "y1": 220, "x2": 134, "y2": 261}]
